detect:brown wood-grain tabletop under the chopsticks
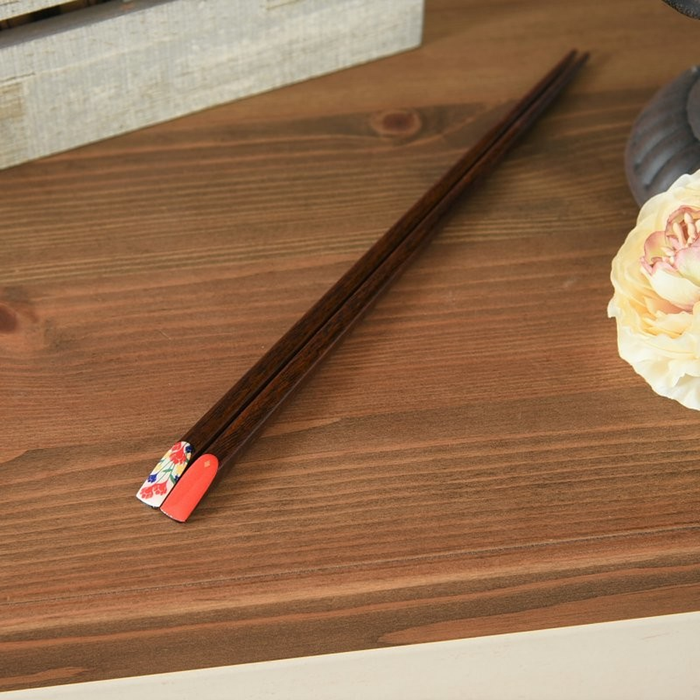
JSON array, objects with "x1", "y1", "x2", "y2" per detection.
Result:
[{"x1": 0, "y1": 0, "x2": 700, "y2": 690}]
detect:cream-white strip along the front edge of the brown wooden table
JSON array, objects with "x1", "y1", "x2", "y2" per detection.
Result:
[{"x1": 2, "y1": 612, "x2": 700, "y2": 700}]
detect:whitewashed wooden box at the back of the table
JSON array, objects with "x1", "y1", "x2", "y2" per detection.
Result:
[{"x1": 0, "y1": 0, "x2": 424, "y2": 168}]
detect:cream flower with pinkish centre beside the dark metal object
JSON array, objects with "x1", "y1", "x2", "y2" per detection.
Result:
[{"x1": 608, "y1": 171, "x2": 700, "y2": 410}]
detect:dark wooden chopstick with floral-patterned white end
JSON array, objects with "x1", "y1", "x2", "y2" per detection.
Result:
[{"x1": 137, "y1": 51, "x2": 576, "y2": 507}]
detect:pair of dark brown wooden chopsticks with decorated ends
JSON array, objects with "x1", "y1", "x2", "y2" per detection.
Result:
[{"x1": 137, "y1": 51, "x2": 588, "y2": 522}]
